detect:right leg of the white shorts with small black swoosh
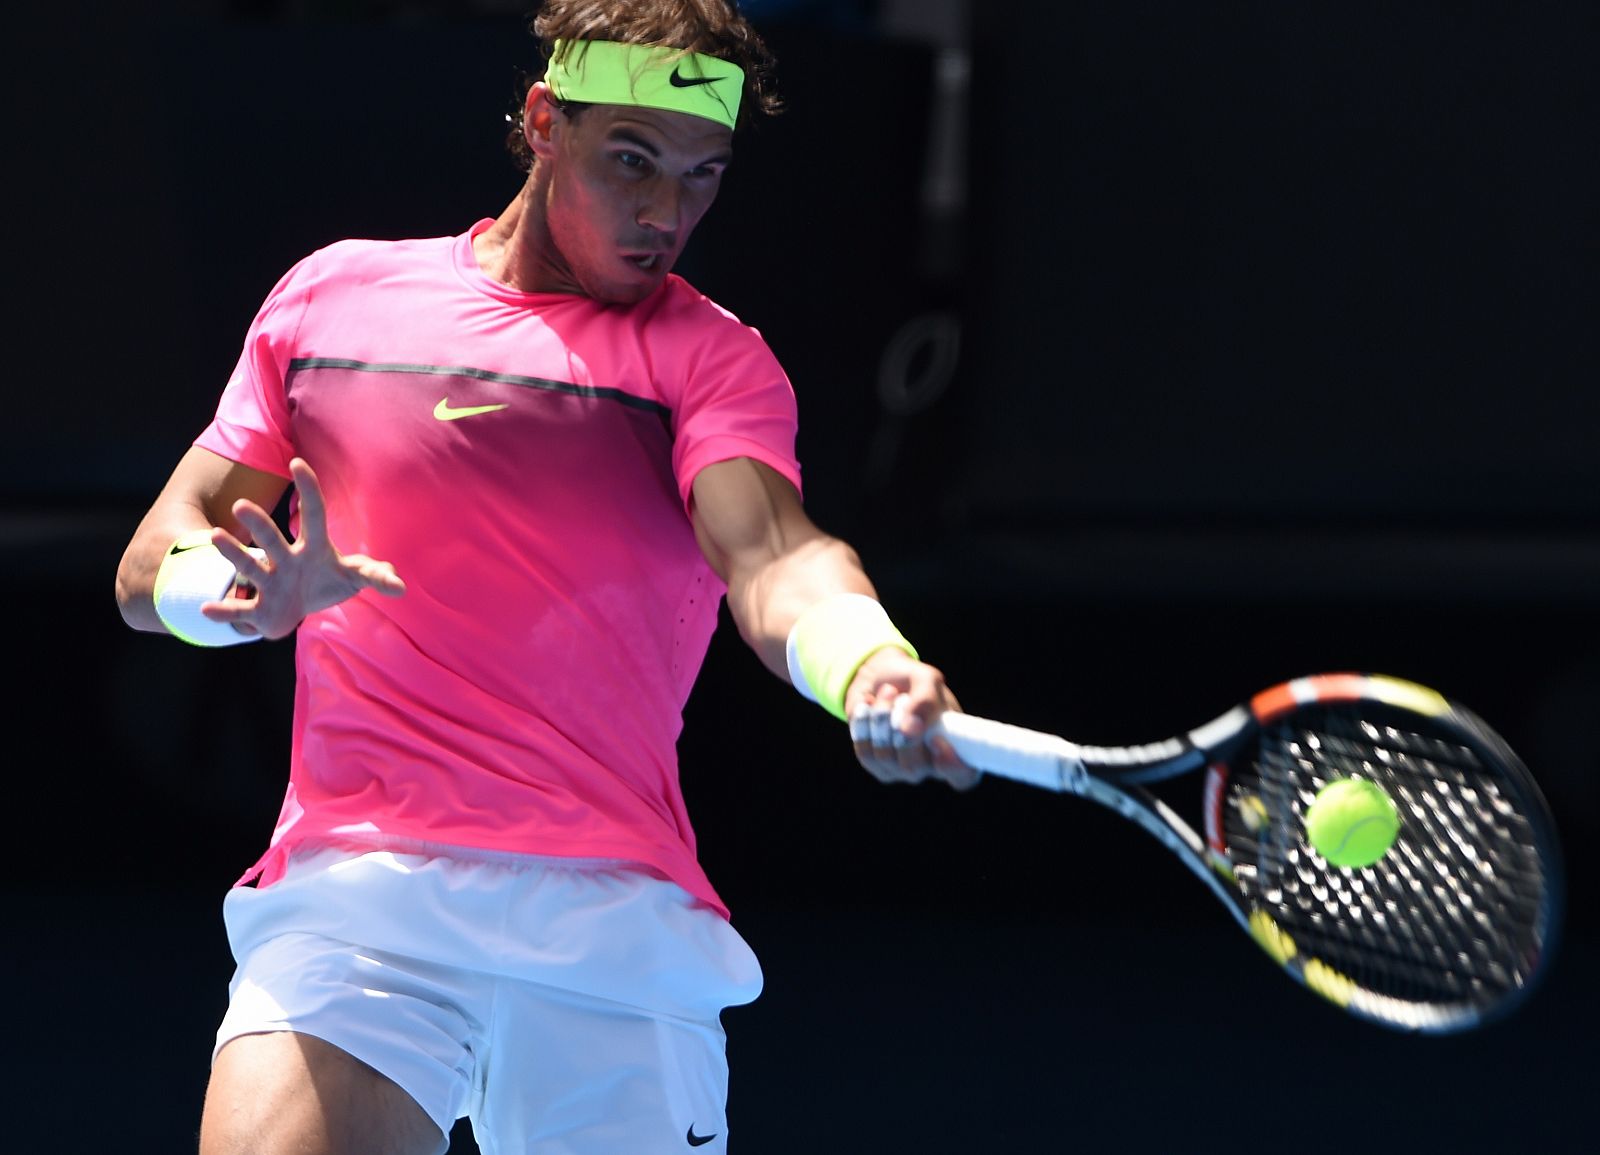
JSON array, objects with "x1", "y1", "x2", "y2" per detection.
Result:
[{"x1": 472, "y1": 981, "x2": 728, "y2": 1155}]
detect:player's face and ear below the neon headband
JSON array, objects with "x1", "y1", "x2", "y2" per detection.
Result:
[{"x1": 525, "y1": 86, "x2": 733, "y2": 304}]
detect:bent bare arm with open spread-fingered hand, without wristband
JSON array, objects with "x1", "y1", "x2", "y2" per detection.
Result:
[{"x1": 117, "y1": 448, "x2": 405, "y2": 638}]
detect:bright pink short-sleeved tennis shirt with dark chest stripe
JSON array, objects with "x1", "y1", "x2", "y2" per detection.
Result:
[{"x1": 195, "y1": 221, "x2": 800, "y2": 915}]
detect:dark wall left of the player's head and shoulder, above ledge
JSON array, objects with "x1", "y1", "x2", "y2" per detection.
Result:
[{"x1": 12, "y1": 3, "x2": 531, "y2": 507}]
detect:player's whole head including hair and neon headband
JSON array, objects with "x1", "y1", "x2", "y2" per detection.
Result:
[{"x1": 518, "y1": 0, "x2": 776, "y2": 304}]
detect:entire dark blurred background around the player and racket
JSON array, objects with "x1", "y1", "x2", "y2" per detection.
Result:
[{"x1": 0, "y1": 0, "x2": 1600, "y2": 1155}]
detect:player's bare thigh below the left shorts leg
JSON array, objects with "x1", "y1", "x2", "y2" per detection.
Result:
[{"x1": 200, "y1": 1030, "x2": 448, "y2": 1155}]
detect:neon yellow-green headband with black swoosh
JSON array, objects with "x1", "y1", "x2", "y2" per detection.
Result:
[{"x1": 544, "y1": 40, "x2": 744, "y2": 128}]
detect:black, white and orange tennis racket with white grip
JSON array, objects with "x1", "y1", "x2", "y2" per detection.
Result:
[{"x1": 931, "y1": 673, "x2": 1563, "y2": 1033}]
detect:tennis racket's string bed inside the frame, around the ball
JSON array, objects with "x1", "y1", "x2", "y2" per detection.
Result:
[{"x1": 1224, "y1": 709, "x2": 1547, "y2": 1006}]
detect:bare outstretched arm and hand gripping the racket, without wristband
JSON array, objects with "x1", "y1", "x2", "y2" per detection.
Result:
[{"x1": 691, "y1": 458, "x2": 978, "y2": 789}]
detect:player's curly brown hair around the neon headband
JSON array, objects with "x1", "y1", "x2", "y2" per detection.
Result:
[{"x1": 506, "y1": 0, "x2": 782, "y2": 171}]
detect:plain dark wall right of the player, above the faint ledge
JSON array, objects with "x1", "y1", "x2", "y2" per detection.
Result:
[{"x1": 958, "y1": 3, "x2": 1600, "y2": 528}]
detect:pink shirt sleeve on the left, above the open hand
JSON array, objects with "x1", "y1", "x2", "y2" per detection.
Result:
[{"x1": 195, "y1": 254, "x2": 315, "y2": 477}]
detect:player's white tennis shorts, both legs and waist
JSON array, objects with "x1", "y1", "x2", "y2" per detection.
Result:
[{"x1": 213, "y1": 849, "x2": 762, "y2": 1155}]
